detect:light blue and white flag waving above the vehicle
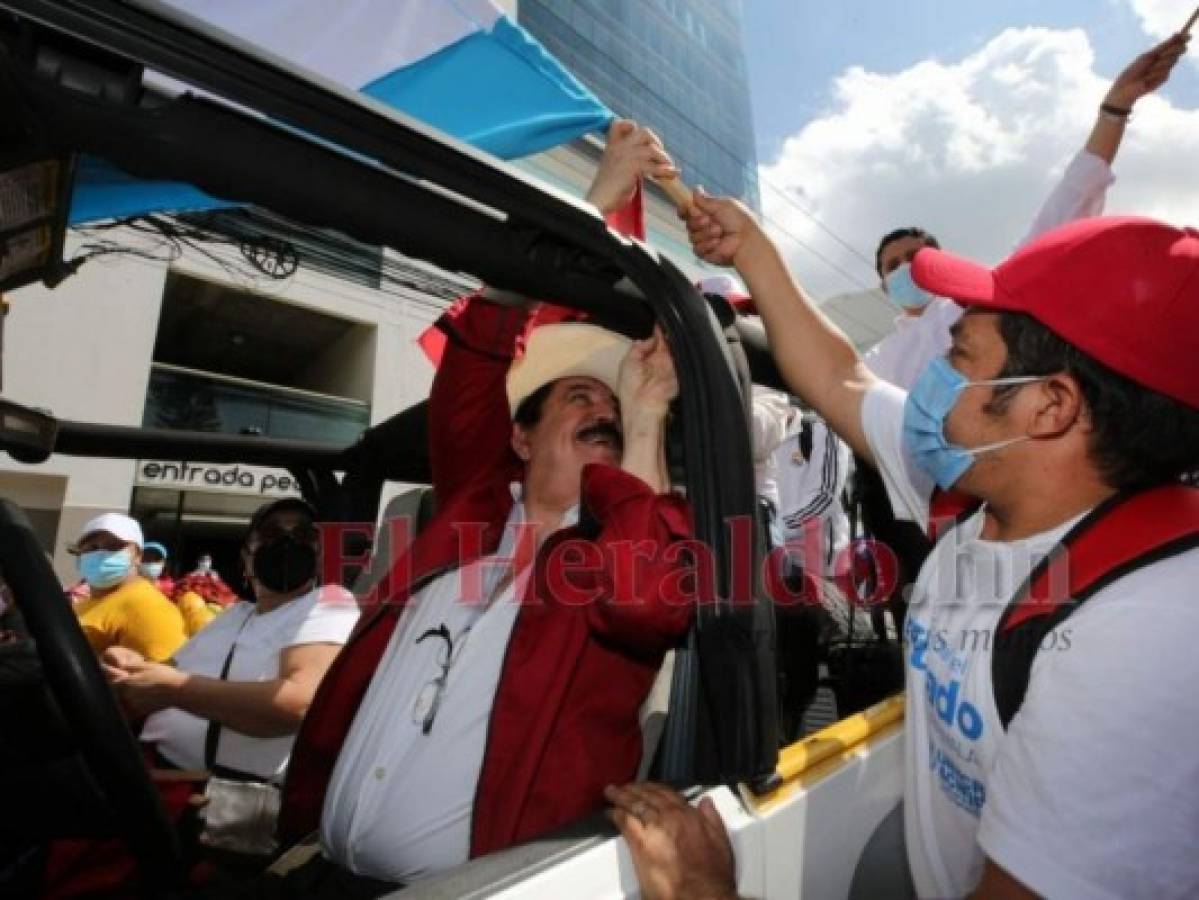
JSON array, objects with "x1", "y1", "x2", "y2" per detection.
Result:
[{"x1": 71, "y1": 0, "x2": 613, "y2": 224}]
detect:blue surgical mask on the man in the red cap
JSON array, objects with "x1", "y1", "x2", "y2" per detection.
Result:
[{"x1": 903, "y1": 356, "x2": 1044, "y2": 490}]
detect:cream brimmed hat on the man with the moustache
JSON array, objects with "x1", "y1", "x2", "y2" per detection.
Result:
[{"x1": 507, "y1": 322, "x2": 633, "y2": 415}]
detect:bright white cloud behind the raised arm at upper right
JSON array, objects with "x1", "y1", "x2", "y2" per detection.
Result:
[{"x1": 761, "y1": 24, "x2": 1199, "y2": 298}]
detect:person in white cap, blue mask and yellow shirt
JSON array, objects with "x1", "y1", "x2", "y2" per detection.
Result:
[{"x1": 70, "y1": 513, "x2": 187, "y2": 662}]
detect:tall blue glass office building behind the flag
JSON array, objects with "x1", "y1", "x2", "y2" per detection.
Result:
[{"x1": 517, "y1": 0, "x2": 759, "y2": 210}]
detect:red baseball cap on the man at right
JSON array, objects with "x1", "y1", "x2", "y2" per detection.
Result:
[{"x1": 911, "y1": 217, "x2": 1199, "y2": 410}]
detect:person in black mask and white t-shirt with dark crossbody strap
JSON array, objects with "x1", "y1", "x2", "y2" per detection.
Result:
[{"x1": 103, "y1": 497, "x2": 359, "y2": 853}]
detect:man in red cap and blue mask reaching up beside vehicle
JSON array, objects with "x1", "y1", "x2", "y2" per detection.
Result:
[{"x1": 609, "y1": 195, "x2": 1199, "y2": 898}]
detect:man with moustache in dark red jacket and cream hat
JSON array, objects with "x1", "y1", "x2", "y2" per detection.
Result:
[{"x1": 263, "y1": 125, "x2": 693, "y2": 894}]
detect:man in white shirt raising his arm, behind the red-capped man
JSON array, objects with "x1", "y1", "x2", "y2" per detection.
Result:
[{"x1": 863, "y1": 35, "x2": 1187, "y2": 389}]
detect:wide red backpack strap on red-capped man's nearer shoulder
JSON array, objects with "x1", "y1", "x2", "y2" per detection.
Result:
[{"x1": 1001, "y1": 484, "x2": 1199, "y2": 632}]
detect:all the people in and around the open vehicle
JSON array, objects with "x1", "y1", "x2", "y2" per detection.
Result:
[{"x1": 4, "y1": 24, "x2": 1199, "y2": 898}]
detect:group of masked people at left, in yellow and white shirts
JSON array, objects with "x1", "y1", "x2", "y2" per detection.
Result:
[{"x1": 42, "y1": 497, "x2": 359, "y2": 896}]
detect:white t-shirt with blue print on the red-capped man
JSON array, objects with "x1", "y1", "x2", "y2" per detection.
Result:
[{"x1": 862, "y1": 383, "x2": 1199, "y2": 900}]
